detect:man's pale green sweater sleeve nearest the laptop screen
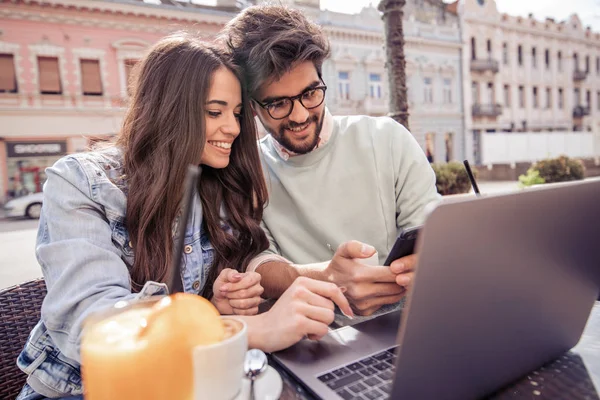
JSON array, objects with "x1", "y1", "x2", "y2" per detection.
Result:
[{"x1": 392, "y1": 122, "x2": 441, "y2": 229}]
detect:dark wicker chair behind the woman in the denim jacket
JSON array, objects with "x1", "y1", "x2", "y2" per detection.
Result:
[{"x1": 0, "y1": 279, "x2": 46, "y2": 399}]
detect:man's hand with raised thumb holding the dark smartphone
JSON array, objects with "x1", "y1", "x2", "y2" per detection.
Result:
[{"x1": 323, "y1": 240, "x2": 405, "y2": 315}]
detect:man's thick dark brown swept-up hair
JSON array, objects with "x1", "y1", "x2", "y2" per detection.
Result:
[{"x1": 220, "y1": 5, "x2": 329, "y2": 96}]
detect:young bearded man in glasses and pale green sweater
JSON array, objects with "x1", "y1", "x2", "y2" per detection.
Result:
[{"x1": 222, "y1": 5, "x2": 439, "y2": 315}]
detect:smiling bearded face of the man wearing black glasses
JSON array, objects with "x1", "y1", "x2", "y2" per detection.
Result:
[{"x1": 253, "y1": 61, "x2": 325, "y2": 154}]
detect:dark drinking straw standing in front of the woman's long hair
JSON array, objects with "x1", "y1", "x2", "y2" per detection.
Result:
[{"x1": 168, "y1": 165, "x2": 200, "y2": 293}]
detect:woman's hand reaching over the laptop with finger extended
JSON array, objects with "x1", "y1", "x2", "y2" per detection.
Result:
[{"x1": 246, "y1": 277, "x2": 354, "y2": 352}]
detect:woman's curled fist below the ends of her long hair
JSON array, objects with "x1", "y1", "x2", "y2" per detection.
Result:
[{"x1": 211, "y1": 268, "x2": 264, "y2": 315}]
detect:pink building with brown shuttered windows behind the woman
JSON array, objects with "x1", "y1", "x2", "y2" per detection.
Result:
[{"x1": 0, "y1": 0, "x2": 236, "y2": 203}]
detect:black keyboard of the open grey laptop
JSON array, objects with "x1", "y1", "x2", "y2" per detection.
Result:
[{"x1": 317, "y1": 347, "x2": 396, "y2": 400}]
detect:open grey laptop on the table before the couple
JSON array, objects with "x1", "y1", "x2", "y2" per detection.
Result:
[{"x1": 273, "y1": 181, "x2": 600, "y2": 400}]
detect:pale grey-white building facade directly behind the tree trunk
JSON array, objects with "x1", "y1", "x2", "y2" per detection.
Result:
[{"x1": 318, "y1": 0, "x2": 465, "y2": 162}]
